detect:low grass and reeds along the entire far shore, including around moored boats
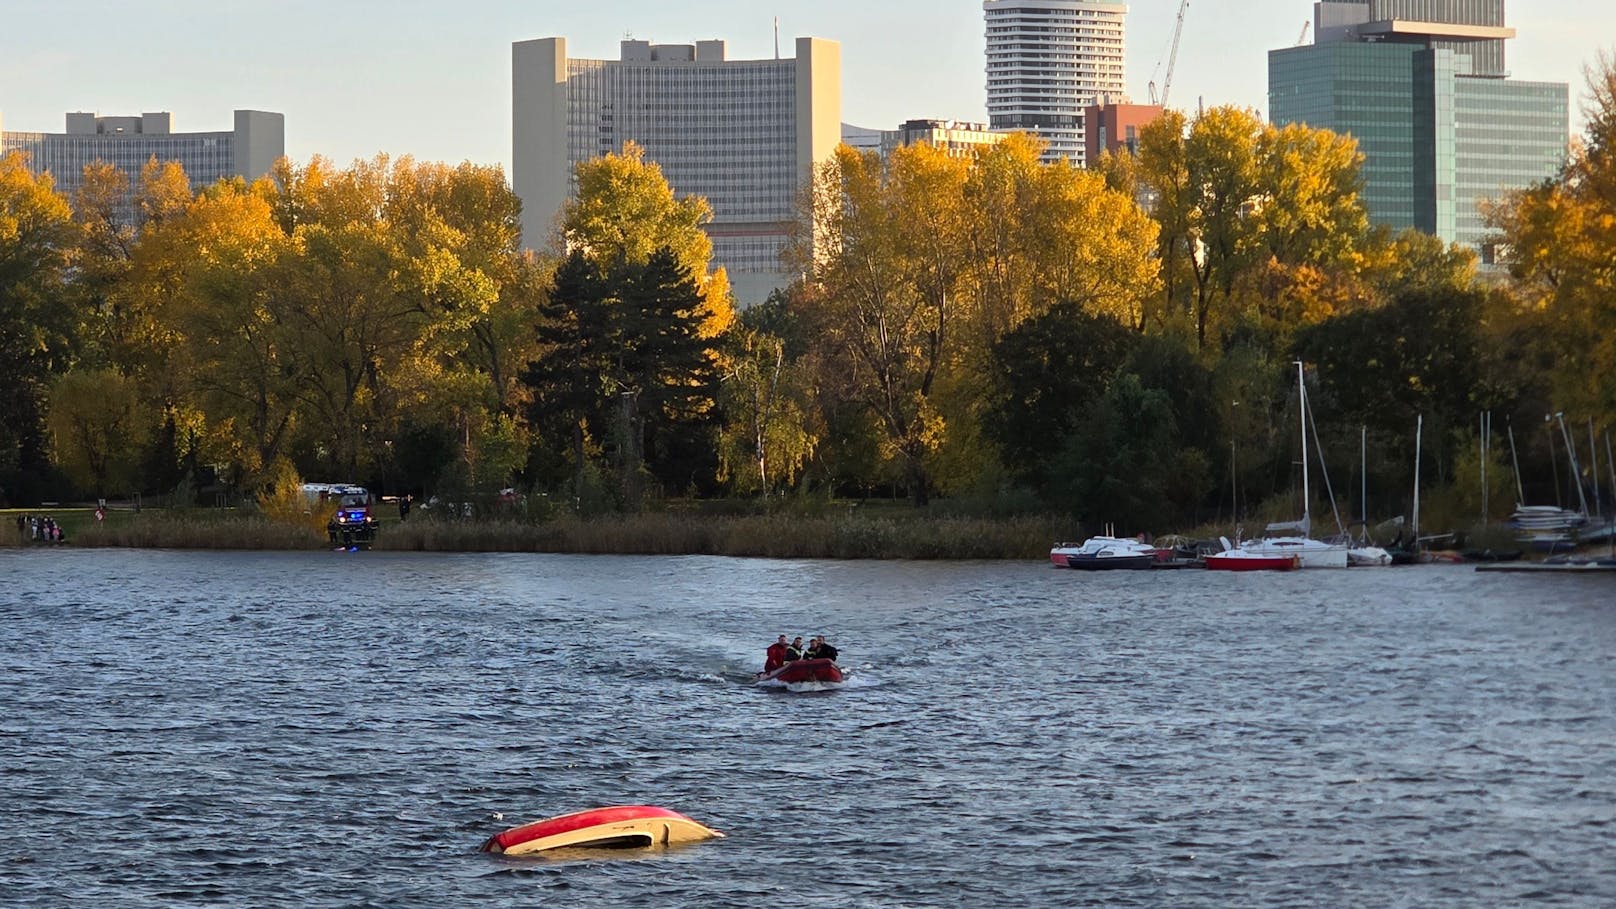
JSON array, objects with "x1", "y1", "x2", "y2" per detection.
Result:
[{"x1": 9, "y1": 501, "x2": 1616, "y2": 561}]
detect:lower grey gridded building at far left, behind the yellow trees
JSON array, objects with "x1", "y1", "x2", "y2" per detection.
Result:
[{"x1": 0, "y1": 110, "x2": 286, "y2": 218}]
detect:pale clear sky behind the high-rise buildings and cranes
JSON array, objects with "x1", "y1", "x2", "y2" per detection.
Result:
[{"x1": 0, "y1": 0, "x2": 1616, "y2": 173}]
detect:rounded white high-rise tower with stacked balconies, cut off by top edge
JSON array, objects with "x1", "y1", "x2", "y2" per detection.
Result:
[{"x1": 983, "y1": 0, "x2": 1128, "y2": 163}]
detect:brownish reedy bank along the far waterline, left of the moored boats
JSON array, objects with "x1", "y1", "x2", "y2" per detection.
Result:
[{"x1": 6, "y1": 509, "x2": 1073, "y2": 560}]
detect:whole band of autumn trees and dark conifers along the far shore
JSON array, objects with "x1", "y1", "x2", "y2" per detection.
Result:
[{"x1": 0, "y1": 65, "x2": 1616, "y2": 532}]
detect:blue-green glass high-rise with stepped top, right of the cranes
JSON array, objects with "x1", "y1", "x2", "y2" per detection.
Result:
[{"x1": 1269, "y1": 0, "x2": 1571, "y2": 249}]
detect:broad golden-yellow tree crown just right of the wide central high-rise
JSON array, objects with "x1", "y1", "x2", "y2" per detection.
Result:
[{"x1": 792, "y1": 136, "x2": 1157, "y2": 505}]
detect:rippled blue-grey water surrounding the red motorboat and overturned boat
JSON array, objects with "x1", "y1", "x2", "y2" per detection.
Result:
[{"x1": 0, "y1": 550, "x2": 1616, "y2": 909}]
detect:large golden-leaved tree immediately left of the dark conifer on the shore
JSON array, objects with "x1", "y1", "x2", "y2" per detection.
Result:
[{"x1": 242, "y1": 157, "x2": 533, "y2": 485}]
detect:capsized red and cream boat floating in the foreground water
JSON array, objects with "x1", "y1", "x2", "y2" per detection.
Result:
[{"x1": 482, "y1": 805, "x2": 724, "y2": 856}]
